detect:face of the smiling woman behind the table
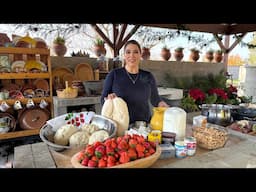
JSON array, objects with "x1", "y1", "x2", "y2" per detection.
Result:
[{"x1": 124, "y1": 44, "x2": 141, "y2": 67}]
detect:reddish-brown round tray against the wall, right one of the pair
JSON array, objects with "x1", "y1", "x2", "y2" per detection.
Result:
[{"x1": 75, "y1": 63, "x2": 94, "y2": 81}]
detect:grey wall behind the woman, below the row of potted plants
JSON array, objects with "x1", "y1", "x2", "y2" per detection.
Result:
[{"x1": 51, "y1": 57, "x2": 224, "y2": 85}]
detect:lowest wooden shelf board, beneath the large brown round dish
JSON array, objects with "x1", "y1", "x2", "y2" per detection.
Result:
[{"x1": 0, "y1": 129, "x2": 40, "y2": 140}]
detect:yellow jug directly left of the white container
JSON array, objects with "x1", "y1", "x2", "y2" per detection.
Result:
[{"x1": 150, "y1": 107, "x2": 167, "y2": 131}]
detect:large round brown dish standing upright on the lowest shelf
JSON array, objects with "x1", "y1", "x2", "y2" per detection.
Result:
[{"x1": 19, "y1": 107, "x2": 50, "y2": 129}]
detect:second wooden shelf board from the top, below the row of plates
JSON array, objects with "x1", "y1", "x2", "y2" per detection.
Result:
[{"x1": 0, "y1": 72, "x2": 50, "y2": 79}]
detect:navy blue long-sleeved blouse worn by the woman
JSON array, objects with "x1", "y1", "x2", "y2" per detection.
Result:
[{"x1": 101, "y1": 67, "x2": 161, "y2": 123}]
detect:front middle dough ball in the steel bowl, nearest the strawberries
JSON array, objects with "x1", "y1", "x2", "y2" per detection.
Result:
[{"x1": 69, "y1": 131, "x2": 90, "y2": 147}]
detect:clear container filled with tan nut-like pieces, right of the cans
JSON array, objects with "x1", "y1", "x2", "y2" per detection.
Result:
[{"x1": 192, "y1": 123, "x2": 228, "y2": 149}]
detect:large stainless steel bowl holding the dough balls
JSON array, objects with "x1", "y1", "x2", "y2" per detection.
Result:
[{"x1": 39, "y1": 115, "x2": 117, "y2": 151}]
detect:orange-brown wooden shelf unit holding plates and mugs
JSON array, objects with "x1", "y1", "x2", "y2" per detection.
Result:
[{"x1": 0, "y1": 47, "x2": 53, "y2": 140}]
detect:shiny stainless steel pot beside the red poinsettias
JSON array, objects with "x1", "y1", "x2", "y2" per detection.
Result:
[{"x1": 201, "y1": 104, "x2": 232, "y2": 126}]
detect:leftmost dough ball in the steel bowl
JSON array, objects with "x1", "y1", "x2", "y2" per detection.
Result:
[{"x1": 54, "y1": 125, "x2": 78, "y2": 145}]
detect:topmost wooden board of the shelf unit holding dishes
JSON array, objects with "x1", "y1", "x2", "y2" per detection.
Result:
[{"x1": 0, "y1": 47, "x2": 50, "y2": 55}]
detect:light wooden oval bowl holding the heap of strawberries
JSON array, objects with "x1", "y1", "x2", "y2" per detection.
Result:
[{"x1": 71, "y1": 146, "x2": 161, "y2": 168}]
